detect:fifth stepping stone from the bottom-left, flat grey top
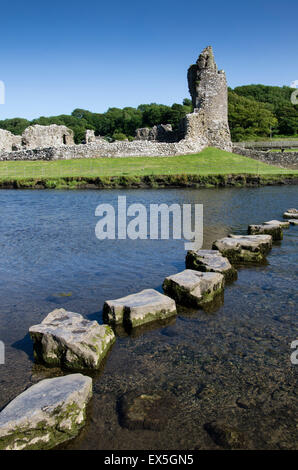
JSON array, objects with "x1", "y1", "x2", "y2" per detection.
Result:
[{"x1": 185, "y1": 250, "x2": 237, "y2": 281}]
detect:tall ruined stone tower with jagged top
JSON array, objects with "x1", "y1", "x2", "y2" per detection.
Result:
[{"x1": 184, "y1": 46, "x2": 232, "y2": 150}]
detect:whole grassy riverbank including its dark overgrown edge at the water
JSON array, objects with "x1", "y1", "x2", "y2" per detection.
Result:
[{"x1": 0, "y1": 148, "x2": 298, "y2": 189}]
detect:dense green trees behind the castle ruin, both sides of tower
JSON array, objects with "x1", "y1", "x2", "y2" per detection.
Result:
[{"x1": 0, "y1": 85, "x2": 298, "y2": 143}]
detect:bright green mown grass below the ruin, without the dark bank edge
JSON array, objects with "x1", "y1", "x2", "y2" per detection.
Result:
[{"x1": 0, "y1": 148, "x2": 298, "y2": 182}]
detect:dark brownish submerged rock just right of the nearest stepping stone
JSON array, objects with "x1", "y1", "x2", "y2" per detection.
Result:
[{"x1": 120, "y1": 392, "x2": 174, "y2": 431}]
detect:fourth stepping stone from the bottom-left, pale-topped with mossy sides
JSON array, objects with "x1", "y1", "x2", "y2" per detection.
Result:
[{"x1": 162, "y1": 269, "x2": 224, "y2": 308}]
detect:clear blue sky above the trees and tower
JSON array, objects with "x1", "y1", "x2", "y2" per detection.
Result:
[{"x1": 0, "y1": 0, "x2": 298, "y2": 119}]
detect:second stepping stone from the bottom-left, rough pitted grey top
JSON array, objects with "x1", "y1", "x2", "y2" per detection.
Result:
[{"x1": 29, "y1": 308, "x2": 115, "y2": 369}]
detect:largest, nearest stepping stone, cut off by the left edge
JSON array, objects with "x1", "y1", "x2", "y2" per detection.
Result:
[{"x1": 0, "y1": 374, "x2": 92, "y2": 450}]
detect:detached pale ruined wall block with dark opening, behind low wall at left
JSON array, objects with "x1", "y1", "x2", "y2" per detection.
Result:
[{"x1": 22, "y1": 124, "x2": 74, "y2": 149}]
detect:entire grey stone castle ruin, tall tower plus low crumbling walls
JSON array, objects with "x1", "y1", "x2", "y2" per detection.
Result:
[{"x1": 0, "y1": 46, "x2": 232, "y2": 160}]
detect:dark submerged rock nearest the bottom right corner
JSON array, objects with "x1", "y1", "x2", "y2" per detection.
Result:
[{"x1": 204, "y1": 421, "x2": 247, "y2": 449}]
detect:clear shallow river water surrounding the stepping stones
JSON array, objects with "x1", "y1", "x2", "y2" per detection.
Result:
[{"x1": 0, "y1": 186, "x2": 298, "y2": 449}]
